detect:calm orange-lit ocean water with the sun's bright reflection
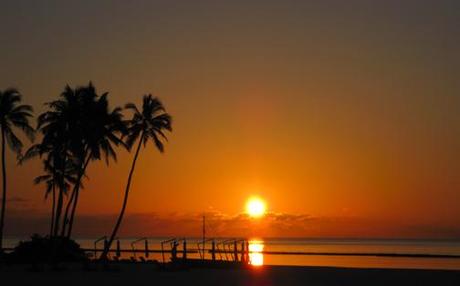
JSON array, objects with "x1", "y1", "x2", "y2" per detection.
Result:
[{"x1": 5, "y1": 238, "x2": 460, "y2": 270}]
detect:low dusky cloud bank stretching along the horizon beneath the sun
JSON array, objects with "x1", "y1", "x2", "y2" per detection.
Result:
[{"x1": 1, "y1": 208, "x2": 460, "y2": 238}]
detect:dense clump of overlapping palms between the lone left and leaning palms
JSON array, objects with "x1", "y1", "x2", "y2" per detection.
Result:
[{"x1": 24, "y1": 82, "x2": 126, "y2": 237}]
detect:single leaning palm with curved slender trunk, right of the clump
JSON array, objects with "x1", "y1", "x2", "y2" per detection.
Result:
[{"x1": 101, "y1": 94, "x2": 172, "y2": 260}]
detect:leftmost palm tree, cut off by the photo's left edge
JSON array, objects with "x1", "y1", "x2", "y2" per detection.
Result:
[{"x1": 0, "y1": 88, "x2": 34, "y2": 252}]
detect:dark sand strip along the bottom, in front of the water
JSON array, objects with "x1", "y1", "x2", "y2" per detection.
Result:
[{"x1": 0, "y1": 264, "x2": 460, "y2": 286}]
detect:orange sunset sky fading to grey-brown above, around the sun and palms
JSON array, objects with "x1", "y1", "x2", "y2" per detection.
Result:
[{"x1": 0, "y1": 0, "x2": 460, "y2": 238}]
